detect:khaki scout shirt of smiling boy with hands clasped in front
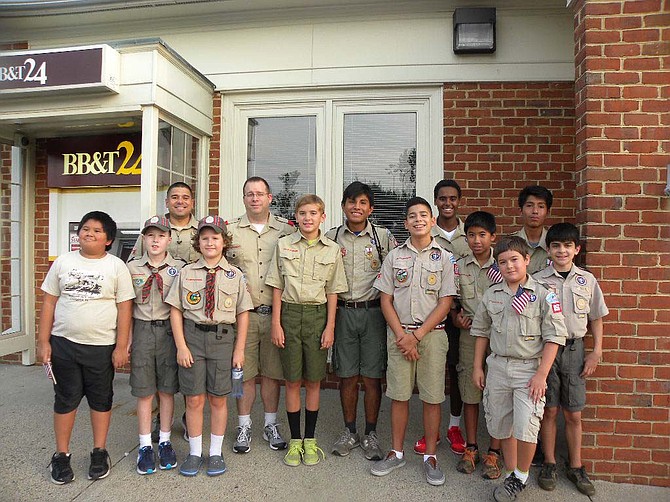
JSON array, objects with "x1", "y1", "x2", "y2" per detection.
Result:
[{"x1": 374, "y1": 239, "x2": 457, "y2": 324}]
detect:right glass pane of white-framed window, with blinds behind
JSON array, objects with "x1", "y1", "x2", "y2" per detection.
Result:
[{"x1": 343, "y1": 113, "x2": 416, "y2": 242}]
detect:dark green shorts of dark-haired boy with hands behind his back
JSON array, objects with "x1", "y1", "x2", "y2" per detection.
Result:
[{"x1": 333, "y1": 307, "x2": 386, "y2": 378}]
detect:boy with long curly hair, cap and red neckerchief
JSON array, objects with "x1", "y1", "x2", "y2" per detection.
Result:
[{"x1": 165, "y1": 216, "x2": 253, "y2": 476}]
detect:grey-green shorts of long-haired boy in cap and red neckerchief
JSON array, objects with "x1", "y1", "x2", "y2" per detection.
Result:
[{"x1": 179, "y1": 319, "x2": 235, "y2": 396}]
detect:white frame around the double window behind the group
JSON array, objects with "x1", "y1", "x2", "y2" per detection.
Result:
[{"x1": 218, "y1": 84, "x2": 444, "y2": 228}]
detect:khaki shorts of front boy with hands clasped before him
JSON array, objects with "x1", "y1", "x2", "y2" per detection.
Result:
[{"x1": 386, "y1": 328, "x2": 449, "y2": 404}]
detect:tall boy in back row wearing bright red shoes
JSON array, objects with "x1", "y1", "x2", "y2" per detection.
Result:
[{"x1": 414, "y1": 180, "x2": 471, "y2": 455}]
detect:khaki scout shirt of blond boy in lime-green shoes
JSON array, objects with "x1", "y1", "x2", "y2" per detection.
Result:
[{"x1": 265, "y1": 232, "x2": 349, "y2": 305}]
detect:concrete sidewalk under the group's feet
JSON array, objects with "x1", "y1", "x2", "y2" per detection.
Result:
[{"x1": 0, "y1": 365, "x2": 670, "y2": 502}]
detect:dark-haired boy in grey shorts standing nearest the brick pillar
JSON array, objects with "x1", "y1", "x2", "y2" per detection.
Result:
[{"x1": 533, "y1": 223, "x2": 609, "y2": 496}]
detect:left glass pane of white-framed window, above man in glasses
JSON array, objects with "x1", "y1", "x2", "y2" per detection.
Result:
[{"x1": 247, "y1": 116, "x2": 316, "y2": 220}]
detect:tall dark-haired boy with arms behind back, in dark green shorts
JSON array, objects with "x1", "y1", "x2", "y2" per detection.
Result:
[{"x1": 326, "y1": 181, "x2": 396, "y2": 460}]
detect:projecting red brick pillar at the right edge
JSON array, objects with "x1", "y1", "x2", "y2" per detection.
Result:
[{"x1": 574, "y1": 0, "x2": 670, "y2": 486}]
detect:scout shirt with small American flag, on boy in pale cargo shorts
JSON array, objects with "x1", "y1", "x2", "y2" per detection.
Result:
[{"x1": 470, "y1": 276, "x2": 568, "y2": 359}]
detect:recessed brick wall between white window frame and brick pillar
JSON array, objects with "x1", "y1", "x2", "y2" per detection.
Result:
[{"x1": 444, "y1": 82, "x2": 576, "y2": 227}]
